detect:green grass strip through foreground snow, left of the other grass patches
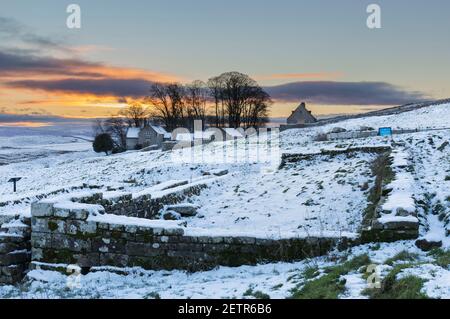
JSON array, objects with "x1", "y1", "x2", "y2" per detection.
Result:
[{"x1": 292, "y1": 255, "x2": 370, "y2": 299}]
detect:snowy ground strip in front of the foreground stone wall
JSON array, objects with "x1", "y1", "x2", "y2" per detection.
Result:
[{"x1": 0, "y1": 241, "x2": 450, "y2": 299}]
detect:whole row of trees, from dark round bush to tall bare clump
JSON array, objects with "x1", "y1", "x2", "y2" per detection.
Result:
[{"x1": 95, "y1": 72, "x2": 272, "y2": 149}]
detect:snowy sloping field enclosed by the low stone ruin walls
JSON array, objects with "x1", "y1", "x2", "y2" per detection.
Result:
[{"x1": 188, "y1": 154, "x2": 375, "y2": 237}]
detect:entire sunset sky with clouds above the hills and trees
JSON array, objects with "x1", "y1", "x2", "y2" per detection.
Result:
[{"x1": 0, "y1": 0, "x2": 450, "y2": 127}]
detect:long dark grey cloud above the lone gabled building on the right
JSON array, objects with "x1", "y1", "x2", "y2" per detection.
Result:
[{"x1": 265, "y1": 81, "x2": 427, "y2": 105}]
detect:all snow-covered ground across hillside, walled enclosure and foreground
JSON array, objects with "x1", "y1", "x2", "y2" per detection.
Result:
[{"x1": 0, "y1": 105, "x2": 450, "y2": 298}]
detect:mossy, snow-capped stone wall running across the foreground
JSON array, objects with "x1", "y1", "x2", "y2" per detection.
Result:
[{"x1": 31, "y1": 203, "x2": 349, "y2": 271}]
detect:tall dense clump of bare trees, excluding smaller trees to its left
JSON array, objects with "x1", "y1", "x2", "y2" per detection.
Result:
[{"x1": 147, "y1": 72, "x2": 272, "y2": 130}]
